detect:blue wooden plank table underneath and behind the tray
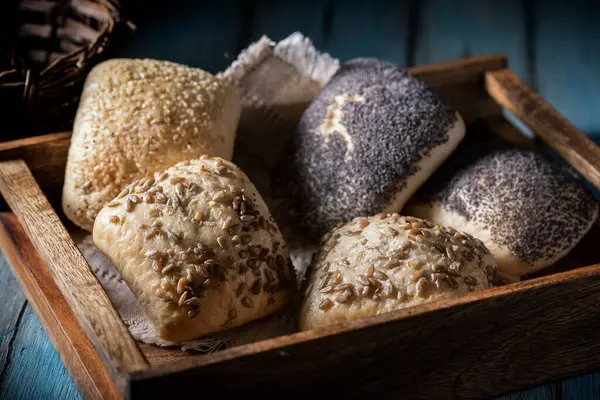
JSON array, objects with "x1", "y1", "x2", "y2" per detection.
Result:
[{"x1": 0, "y1": 0, "x2": 600, "y2": 400}]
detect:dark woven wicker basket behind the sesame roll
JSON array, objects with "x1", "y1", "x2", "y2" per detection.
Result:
[{"x1": 0, "y1": 0, "x2": 133, "y2": 140}]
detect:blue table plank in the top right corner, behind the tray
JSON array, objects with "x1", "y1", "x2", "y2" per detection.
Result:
[{"x1": 533, "y1": 0, "x2": 600, "y2": 135}]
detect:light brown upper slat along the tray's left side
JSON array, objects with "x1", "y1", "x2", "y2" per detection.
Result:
[{"x1": 0, "y1": 160, "x2": 148, "y2": 375}]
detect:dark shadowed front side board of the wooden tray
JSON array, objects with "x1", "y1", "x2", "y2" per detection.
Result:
[{"x1": 132, "y1": 264, "x2": 600, "y2": 399}]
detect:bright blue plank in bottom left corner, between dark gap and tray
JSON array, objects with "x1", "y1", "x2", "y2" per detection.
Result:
[{"x1": 0, "y1": 307, "x2": 81, "y2": 400}]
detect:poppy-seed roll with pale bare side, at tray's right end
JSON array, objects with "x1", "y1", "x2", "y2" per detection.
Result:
[{"x1": 403, "y1": 149, "x2": 598, "y2": 277}]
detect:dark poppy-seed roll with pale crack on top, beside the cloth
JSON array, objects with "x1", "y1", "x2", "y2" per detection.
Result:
[{"x1": 276, "y1": 59, "x2": 465, "y2": 237}]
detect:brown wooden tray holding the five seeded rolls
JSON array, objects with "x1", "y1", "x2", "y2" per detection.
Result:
[{"x1": 0, "y1": 56, "x2": 600, "y2": 399}]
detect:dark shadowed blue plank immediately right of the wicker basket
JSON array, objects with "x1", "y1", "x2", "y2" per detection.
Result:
[{"x1": 119, "y1": 0, "x2": 242, "y2": 73}]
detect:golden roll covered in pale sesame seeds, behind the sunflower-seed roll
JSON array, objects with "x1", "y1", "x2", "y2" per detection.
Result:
[{"x1": 63, "y1": 59, "x2": 240, "y2": 231}]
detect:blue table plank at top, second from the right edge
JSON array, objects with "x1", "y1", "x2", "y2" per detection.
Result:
[{"x1": 415, "y1": 0, "x2": 530, "y2": 80}]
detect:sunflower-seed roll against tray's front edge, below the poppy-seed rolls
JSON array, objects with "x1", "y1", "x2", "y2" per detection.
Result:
[{"x1": 300, "y1": 214, "x2": 498, "y2": 330}]
